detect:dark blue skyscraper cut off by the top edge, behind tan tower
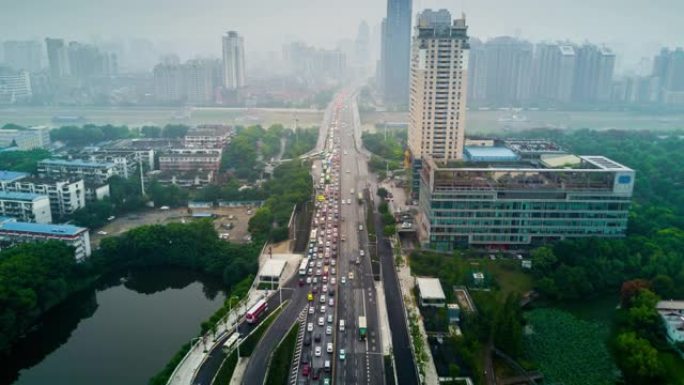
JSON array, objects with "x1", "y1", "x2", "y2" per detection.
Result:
[{"x1": 381, "y1": 0, "x2": 412, "y2": 105}]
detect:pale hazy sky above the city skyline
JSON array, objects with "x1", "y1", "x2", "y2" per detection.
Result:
[{"x1": 0, "y1": 0, "x2": 684, "y2": 72}]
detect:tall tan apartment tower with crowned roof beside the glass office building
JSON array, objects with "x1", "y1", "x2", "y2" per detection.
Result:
[{"x1": 408, "y1": 9, "x2": 469, "y2": 161}]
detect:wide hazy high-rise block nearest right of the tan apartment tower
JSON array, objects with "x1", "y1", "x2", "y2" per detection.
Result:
[{"x1": 485, "y1": 36, "x2": 533, "y2": 105}]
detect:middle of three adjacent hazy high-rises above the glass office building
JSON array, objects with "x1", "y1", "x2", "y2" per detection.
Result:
[{"x1": 532, "y1": 43, "x2": 575, "y2": 102}]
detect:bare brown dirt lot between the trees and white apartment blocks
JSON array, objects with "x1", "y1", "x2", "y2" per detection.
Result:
[{"x1": 90, "y1": 207, "x2": 254, "y2": 248}]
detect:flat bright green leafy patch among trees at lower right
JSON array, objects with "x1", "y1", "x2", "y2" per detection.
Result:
[{"x1": 523, "y1": 309, "x2": 619, "y2": 385}]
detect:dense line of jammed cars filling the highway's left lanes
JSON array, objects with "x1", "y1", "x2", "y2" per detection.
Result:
[{"x1": 299, "y1": 98, "x2": 346, "y2": 384}]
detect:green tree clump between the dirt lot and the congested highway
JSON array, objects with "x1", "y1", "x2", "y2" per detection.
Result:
[{"x1": 249, "y1": 161, "x2": 313, "y2": 242}]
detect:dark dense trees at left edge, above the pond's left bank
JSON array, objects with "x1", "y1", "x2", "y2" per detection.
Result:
[{"x1": 0, "y1": 241, "x2": 87, "y2": 352}]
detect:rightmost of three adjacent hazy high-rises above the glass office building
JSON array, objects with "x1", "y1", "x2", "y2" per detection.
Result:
[{"x1": 573, "y1": 44, "x2": 615, "y2": 103}]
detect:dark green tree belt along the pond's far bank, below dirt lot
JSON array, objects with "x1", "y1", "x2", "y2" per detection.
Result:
[{"x1": 93, "y1": 220, "x2": 259, "y2": 287}]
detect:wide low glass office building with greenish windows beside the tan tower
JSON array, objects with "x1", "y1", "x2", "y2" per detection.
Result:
[{"x1": 419, "y1": 141, "x2": 634, "y2": 251}]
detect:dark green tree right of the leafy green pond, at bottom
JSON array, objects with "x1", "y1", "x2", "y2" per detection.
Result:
[{"x1": 615, "y1": 332, "x2": 664, "y2": 384}]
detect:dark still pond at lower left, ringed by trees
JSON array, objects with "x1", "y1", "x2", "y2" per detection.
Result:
[{"x1": 0, "y1": 269, "x2": 225, "y2": 385}]
